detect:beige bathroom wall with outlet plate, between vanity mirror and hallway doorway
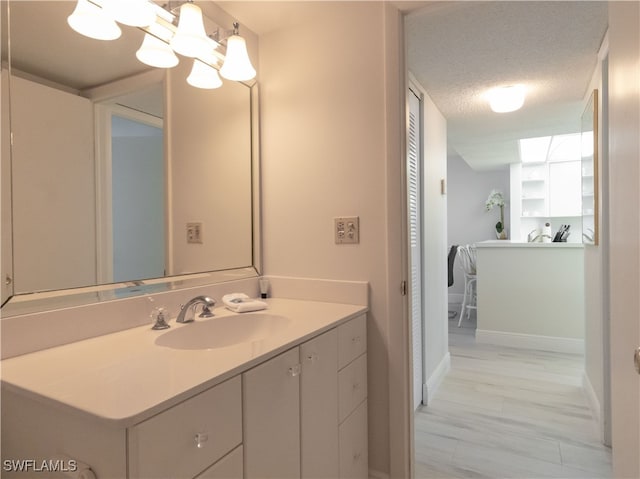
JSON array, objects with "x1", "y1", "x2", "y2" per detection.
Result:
[{"x1": 259, "y1": 2, "x2": 408, "y2": 472}]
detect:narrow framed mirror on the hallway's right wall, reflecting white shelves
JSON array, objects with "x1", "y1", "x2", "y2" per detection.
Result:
[{"x1": 580, "y1": 89, "x2": 600, "y2": 246}]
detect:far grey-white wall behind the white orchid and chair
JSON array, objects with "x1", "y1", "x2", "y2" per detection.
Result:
[{"x1": 447, "y1": 153, "x2": 511, "y2": 302}]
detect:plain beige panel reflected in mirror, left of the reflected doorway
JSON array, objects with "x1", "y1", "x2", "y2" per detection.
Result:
[{"x1": 11, "y1": 76, "x2": 96, "y2": 293}]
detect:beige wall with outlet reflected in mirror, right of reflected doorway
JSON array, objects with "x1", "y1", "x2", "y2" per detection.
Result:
[{"x1": 165, "y1": 61, "x2": 253, "y2": 275}]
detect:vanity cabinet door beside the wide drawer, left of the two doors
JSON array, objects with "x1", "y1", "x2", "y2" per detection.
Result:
[{"x1": 242, "y1": 347, "x2": 301, "y2": 479}]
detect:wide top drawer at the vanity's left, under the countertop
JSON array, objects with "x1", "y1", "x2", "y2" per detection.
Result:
[{"x1": 127, "y1": 377, "x2": 242, "y2": 479}]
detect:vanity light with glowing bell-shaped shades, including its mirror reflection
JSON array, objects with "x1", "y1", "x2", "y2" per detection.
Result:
[{"x1": 67, "y1": 0, "x2": 256, "y2": 89}]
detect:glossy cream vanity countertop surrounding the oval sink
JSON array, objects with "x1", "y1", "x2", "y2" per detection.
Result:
[{"x1": 0, "y1": 299, "x2": 367, "y2": 427}]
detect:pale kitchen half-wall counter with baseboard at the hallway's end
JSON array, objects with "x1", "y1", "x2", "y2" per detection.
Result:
[{"x1": 476, "y1": 241, "x2": 584, "y2": 353}]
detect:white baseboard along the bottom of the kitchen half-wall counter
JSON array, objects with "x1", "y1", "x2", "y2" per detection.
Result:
[{"x1": 476, "y1": 329, "x2": 584, "y2": 354}]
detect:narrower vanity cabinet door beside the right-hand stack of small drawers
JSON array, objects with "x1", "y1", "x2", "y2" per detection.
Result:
[{"x1": 300, "y1": 329, "x2": 339, "y2": 479}]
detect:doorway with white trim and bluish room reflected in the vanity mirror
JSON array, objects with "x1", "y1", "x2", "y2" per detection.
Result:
[{"x1": 96, "y1": 103, "x2": 167, "y2": 283}]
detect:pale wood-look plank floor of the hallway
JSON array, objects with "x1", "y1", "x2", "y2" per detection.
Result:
[{"x1": 415, "y1": 317, "x2": 611, "y2": 479}]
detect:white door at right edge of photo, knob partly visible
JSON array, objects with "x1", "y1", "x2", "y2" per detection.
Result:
[{"x1": 609, "y1": 2, "x2": 640, "y2": 478}]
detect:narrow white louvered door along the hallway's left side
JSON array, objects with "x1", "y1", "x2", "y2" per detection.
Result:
[{"x1": 407, "y1": 89, "x2": 424, "y2": 410}]
